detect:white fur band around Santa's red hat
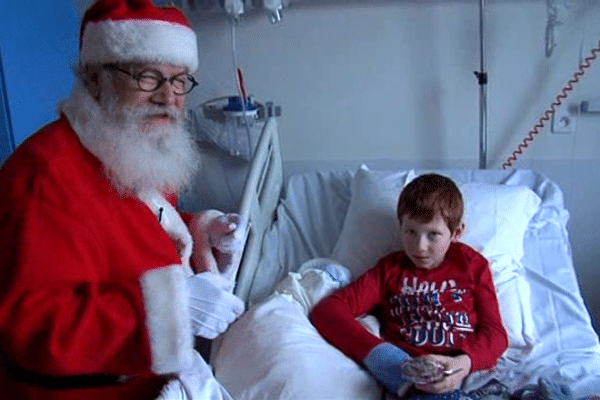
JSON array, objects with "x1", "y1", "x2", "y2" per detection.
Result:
[{"x1": 80, "y1": 20, "x2": 198, "y2": 72}]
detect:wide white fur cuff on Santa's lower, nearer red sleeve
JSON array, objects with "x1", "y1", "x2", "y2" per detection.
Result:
[{"x1": 141, "y1": 265, "x2": 194, "y2": 374}]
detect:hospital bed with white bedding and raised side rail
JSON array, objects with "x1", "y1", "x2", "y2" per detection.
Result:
[{"x1": 211, "y1": 118, "x2": 600, "y2": 400}]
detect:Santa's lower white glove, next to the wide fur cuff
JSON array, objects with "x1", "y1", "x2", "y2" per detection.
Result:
[{"x1": 186, "y1": 272, "x2": 244, "y2": 339}]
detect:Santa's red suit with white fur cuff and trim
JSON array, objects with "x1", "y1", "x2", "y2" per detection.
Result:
[{"x1": 0, "y1": 116, "x2": 193, "y2": 400}]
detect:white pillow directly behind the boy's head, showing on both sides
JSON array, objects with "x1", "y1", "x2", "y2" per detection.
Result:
[{"x1": 331, "y1": 164, "x2": 541, "y2": 279}]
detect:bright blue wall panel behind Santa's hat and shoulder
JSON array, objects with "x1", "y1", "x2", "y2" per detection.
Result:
[{"x1": 0, "y1": 0, "x2": 79, "y2": 146}]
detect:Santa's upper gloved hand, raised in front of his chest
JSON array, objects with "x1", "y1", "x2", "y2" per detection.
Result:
[{"x1": 190, "y1": 210, "x2": 245, "y2": 276}]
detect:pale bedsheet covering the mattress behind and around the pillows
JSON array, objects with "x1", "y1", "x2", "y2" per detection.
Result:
[{"x1": 219, "y1": 170, "x2": 600, "y2": 398}]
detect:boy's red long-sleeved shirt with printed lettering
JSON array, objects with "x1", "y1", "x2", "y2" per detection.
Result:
[{"x1": 310, "y1": 242, "x2": 508, "y2": 371}]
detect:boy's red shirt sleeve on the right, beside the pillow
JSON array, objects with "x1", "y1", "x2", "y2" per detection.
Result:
[{"x1": 463, "y1": 257, "x2": 508, "y2": 371}]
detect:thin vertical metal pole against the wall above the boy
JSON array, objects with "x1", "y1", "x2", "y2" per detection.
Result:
[{"x1": 475, "y1": 0, "x2": 487, "y2": 169}]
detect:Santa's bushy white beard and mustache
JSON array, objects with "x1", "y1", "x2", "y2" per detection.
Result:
[{"x1": 61, "y1": 82, "x2": 200, "y2": 194}]
